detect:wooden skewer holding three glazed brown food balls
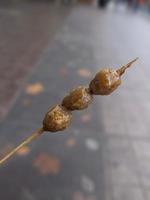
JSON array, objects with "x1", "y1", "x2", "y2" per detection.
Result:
[{"x1": 0, "y1": 58, "x2": 138, "y2": 165}]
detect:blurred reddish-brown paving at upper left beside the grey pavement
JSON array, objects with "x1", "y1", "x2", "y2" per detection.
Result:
[{"x1": 0, "y1": 2, "x2": 70, "y2": 120}]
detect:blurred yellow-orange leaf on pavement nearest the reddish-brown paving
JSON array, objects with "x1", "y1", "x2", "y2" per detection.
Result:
[{"x1": 25, "y1": 82, "x2": 44, "y2": 95}]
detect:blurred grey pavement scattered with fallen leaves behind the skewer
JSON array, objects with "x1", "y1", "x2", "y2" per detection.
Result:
[{"x1": 0, "y1": 2, "x2": 150, "y2": 200}]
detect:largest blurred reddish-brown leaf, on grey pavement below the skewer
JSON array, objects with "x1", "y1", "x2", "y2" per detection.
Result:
[{"x1": 33, "y1": 153, "x2": 60, "y2": 175}]
